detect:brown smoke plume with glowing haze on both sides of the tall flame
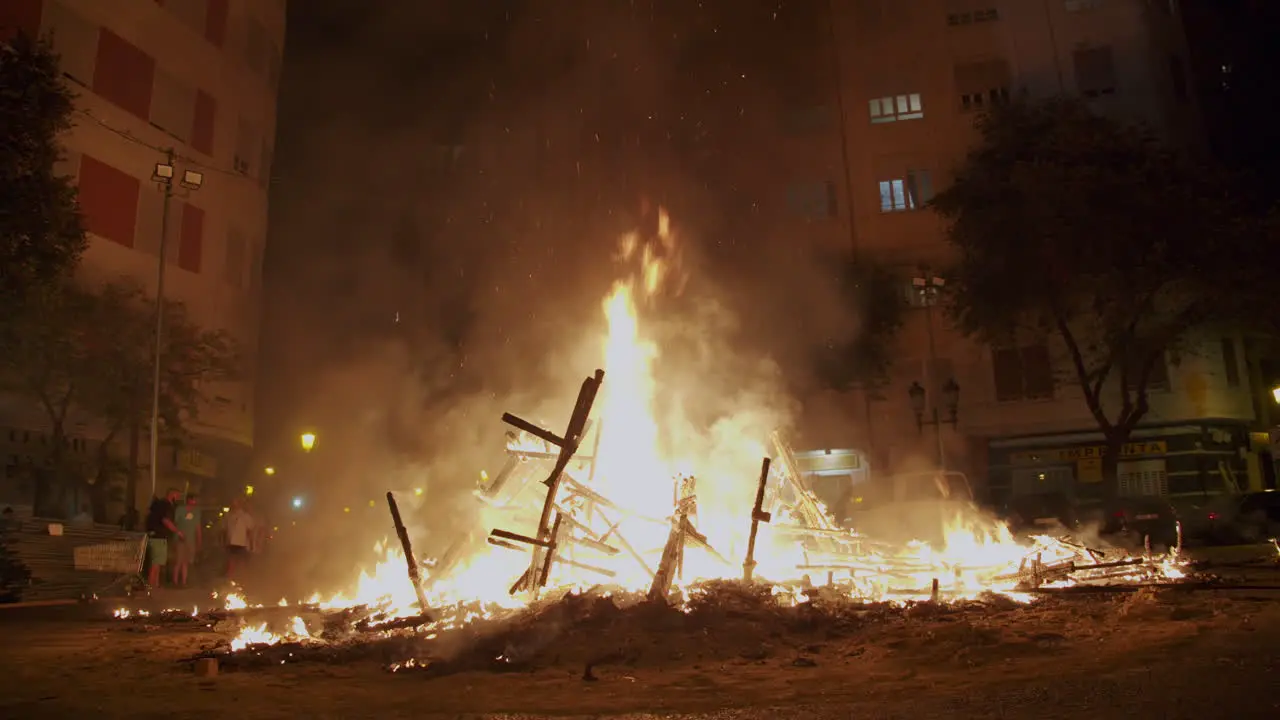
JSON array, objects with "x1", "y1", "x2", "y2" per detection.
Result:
[{"x1": 259, "y1": 1, "x2": 880, "y2": 594}]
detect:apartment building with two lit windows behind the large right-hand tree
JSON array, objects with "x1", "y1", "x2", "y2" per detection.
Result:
[{"x1": 773, "y1": 0, "x2": 1258, "y2": 502}]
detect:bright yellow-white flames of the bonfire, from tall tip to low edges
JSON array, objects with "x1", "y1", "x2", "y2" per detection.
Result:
[{"x1": 162, "y1": 213, "x2": 1181, "y2": 650}]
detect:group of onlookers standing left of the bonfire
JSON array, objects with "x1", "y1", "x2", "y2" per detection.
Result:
[{"x1": 146, "y1": 489, "x2": 261, "y2": 588}]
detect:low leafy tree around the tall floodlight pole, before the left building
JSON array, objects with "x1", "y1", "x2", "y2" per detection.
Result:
[{"x1": 0, "y1": 281, "x2": 237, "y2": 519}]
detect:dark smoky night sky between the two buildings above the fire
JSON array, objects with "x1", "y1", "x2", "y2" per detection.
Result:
[{"x1": 259, "y1": 0, "x2": 851, "y2": 474}]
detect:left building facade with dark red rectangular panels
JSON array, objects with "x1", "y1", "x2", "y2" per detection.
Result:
[{"x1": 0, "y1": 0, "x2": 285, "y2": 515}]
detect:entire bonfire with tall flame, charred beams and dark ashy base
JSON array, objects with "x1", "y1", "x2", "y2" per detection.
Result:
[{"x1": 107, "y1": 210, "x2": 1208, "y2": 671}]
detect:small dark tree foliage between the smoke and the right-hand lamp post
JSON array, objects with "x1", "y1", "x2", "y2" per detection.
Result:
[{"x1": 818, "y1": 259, "x2": 906, "y2": 391}]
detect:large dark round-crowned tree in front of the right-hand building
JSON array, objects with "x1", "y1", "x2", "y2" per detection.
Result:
[{"x1": 933, "y1": 99, "x2": 1263, "y2": 496}]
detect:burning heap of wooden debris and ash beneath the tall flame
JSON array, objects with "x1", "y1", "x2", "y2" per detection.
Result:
[{"x1": 118, "y1": 370, "x2": 1208, "y2": 674}]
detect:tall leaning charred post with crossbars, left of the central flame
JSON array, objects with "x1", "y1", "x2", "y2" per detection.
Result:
[{"x1": 493, "y1": 370, "x2": 604, "y2": 594}]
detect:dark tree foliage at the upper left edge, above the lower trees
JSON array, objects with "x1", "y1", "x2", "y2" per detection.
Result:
[{"x1": 0, "y1": 35, "x2": 86, "y2": 311}]
